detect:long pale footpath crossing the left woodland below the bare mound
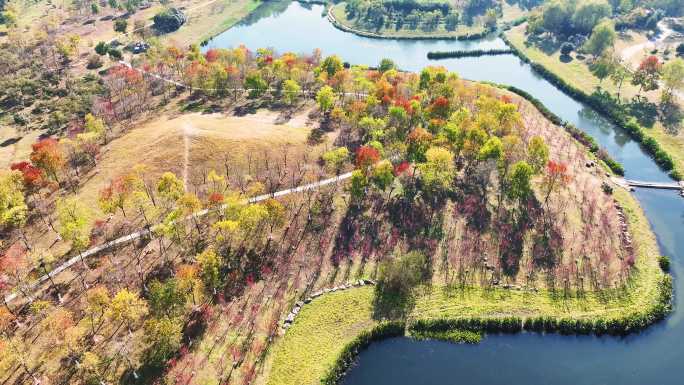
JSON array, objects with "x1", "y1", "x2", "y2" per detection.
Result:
[{"x1": 5, "y1": 172, "x2": 352, "y2": 304}]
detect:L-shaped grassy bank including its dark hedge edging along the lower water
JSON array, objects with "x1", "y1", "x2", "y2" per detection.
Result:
[{"x1": 267, "y1": 134, "x2": 672, "y2": 385}]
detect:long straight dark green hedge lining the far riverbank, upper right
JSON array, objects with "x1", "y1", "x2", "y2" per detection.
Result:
[{"x1": 501, "y1": 34, "x2": 683, "y2": 180}]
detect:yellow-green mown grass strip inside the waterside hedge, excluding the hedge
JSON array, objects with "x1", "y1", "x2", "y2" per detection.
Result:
[{"x1": 266, "y1": 188, "x2": 663, "y2": 385}]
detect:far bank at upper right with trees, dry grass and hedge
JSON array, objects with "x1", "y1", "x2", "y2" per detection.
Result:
[{"x1": 503, "y1": 1, "x2": 684, "y2": 179}]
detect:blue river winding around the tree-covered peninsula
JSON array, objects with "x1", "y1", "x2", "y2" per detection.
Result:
[{"x1": 206, "y1": 2, "x2": 684, "y2": 385}]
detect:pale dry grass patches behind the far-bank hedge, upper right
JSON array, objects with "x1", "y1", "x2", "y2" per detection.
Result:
[{"x1": 506, "y1": 24, "x2": 684, "y2": 178}]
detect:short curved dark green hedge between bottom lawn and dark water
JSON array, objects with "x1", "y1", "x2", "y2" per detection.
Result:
[{"x1": 321, "y1": 321, "x2": 406, "y2": 385}]
